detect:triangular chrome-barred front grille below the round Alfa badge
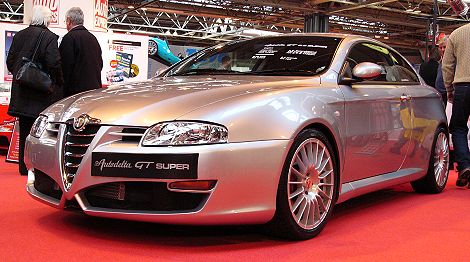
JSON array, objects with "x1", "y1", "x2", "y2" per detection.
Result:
[{"x1": 63, "y1": 124, "x2": 100, "y2": 189}]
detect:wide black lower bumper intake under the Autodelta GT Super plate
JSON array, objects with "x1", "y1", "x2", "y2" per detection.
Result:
[{"x1": 85, "y1": 182, "x2": 209, "y2": 212}]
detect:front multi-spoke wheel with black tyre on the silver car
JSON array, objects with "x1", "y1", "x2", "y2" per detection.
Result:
[{"x1": 267, "y1": 129, "x2": 339, "y2": 240}]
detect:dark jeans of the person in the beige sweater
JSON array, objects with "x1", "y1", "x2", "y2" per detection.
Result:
[{"x1": 449, "y1": 83, "x2": 470, "y2": 171}]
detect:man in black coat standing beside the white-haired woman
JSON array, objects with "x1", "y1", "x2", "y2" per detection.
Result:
[{"x1": 59, "y1": 7, "x2": 103, "y2": 96}]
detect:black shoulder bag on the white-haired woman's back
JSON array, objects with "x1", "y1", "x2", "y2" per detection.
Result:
[{"x1": 16, "y1": 30, "x2": 52, "y2": 93}]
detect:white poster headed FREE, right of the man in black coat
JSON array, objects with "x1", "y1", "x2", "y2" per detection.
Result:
[{"x1": 103, "y1": 35, "x2": 148, "y2": 85}]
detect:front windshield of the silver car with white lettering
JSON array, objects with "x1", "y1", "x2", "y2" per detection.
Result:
[{"x1": 166, "y1": 35, "x2": 341, "y2": 76}]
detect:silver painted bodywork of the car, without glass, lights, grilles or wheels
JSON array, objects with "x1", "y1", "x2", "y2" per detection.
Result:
[{"x1": 25, "y1": 32, "x2": 446, "y2": 225}]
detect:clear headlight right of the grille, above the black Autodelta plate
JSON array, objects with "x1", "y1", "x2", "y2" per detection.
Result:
[{"x1": 142, "y1": 121, "x2": 228, "y2": 146}]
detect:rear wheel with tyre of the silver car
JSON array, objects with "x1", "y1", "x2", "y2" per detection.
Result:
[{"x1": 411, "y1": 127, "x2": 449, "y2": 194}]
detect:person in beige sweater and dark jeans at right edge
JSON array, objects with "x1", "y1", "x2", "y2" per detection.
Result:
[{"x1": 442, "y1": 24, "x2": 470, "y2": 187}]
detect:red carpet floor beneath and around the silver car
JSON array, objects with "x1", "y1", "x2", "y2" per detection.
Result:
[{"x1": 0, "y1": 157, "x2": 470, "y2": 262}]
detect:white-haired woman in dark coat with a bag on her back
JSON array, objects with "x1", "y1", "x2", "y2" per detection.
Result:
[{"x1": 7, "y1": 6, "x2": 63, "y2": 175}]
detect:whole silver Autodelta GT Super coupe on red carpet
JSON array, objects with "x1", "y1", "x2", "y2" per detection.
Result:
[{"x1": 25, "y1": 34, "x2": 449, "y2": 239}]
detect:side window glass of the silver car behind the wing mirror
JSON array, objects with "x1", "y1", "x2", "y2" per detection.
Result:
[{"x1": 343, "y1": 43, "x2": 418, "y2": 83}]
